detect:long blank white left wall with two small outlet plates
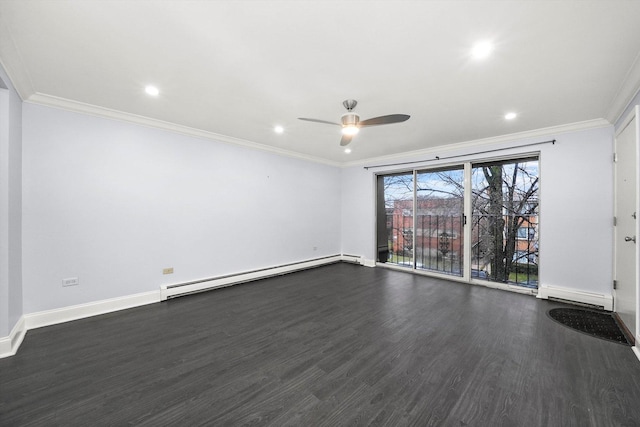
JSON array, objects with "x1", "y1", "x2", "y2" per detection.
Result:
[{"x1": 21, "y1": 103, "x2": 341, "y2": 314}]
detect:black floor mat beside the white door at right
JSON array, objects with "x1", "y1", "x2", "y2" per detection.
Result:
[{"x1": 549, "y1": 308, "x2": 631, "y2": 346}]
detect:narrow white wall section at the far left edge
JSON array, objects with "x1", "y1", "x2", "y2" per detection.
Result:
[{"x1": 0, "y1": 67, "x2": 22, "y2": 337}]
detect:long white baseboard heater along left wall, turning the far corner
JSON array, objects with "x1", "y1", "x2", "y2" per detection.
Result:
[{"x1": 160, "y1": 255, "x2": 362, "y2": 301}]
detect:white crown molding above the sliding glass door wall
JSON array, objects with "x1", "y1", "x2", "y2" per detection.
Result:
[{"x1": 342, "y1": 119, "x2": 612, "y2": 168}]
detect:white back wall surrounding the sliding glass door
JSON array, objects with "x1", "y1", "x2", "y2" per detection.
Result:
[{"x1": 342, "y1": 126, "x2": 613, "y2": 295}]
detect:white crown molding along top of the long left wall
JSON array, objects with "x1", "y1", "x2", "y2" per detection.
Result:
[{"x1": 25, "y1": 93, "x2": 341, "y2": 167}]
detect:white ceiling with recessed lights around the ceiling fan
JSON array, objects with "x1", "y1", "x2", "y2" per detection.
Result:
[{"x1": 0, "y1": 0, "x2": 640, "y2": 164}]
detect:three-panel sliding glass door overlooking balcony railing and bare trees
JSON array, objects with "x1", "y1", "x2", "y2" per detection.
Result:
[{"x1": 377, "y1": 156, "x2": 539, "y2": 288}]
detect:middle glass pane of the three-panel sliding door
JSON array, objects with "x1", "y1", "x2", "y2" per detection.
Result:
[{"x1": 414, "y1": 167, "x2": 464, "y2": 276}]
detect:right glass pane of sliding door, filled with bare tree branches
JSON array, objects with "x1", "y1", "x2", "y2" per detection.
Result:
[{"x1": 471, "y1": 158, "x2": 540, "y2": 288}]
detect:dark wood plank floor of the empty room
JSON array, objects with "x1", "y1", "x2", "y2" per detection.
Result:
[{"x1": 0, "y1": 264, "x2": 640, "y2": 427}]
